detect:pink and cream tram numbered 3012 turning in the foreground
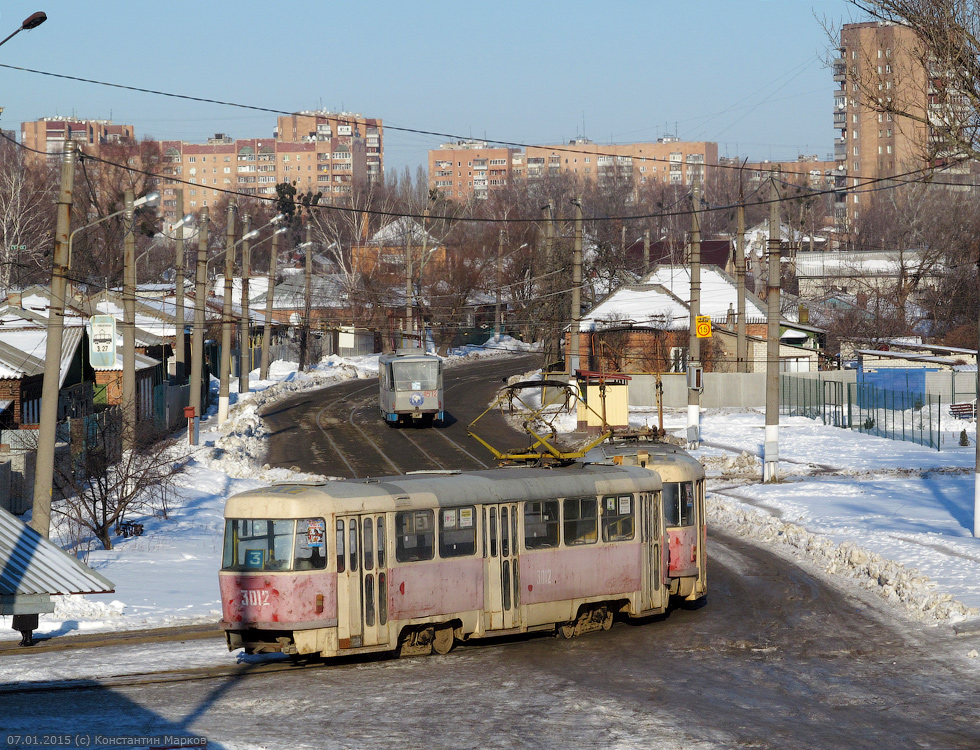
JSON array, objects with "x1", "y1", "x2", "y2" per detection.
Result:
[{"x1": 219, "y1": 445, "x2": 707, "y2": 656}]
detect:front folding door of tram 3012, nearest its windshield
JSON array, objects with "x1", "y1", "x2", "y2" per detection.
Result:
[{"x1": 336, "y1": 514, "x2": 388, "y2": 648}]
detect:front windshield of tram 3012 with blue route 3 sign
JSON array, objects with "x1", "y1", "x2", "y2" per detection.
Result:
[{"x1": 221, "y1": 518, "x2": 327, "y2": 571}]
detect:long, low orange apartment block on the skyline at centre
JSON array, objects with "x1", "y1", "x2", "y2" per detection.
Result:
[{"x1": 429, "y1": 138, "x2": 718, "y2": 200}]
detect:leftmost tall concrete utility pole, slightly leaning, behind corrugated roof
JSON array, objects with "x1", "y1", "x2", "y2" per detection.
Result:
[{"x1": 31, "y1": 141, "x2": 75, "y2": 537}]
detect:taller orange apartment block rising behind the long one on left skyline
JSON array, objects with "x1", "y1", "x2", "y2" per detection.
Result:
[{"x1": 275, "y1": 110, "x2": 384, "y2": 187}]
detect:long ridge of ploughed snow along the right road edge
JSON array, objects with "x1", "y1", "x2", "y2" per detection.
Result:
[{"x1": 708, "y1": 494, "x2": 980, "y2": 624}]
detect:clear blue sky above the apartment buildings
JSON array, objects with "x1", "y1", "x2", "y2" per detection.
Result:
[{"x1": 0, "y1": 0, "x2": 861, "y2": 172}]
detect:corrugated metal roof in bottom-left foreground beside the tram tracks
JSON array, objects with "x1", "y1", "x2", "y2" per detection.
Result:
[{"x1": 0, "y1": 508, "x2": 115, "y2": 596}]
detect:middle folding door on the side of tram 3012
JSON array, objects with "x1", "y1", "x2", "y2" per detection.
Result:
[{"x1": 483, "y1": 504, "x2": 521, "y2": 630}]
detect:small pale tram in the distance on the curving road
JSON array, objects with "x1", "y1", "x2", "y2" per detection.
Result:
[{"x1": 378, "y1": 349, "x2": 445, "y2": 426}]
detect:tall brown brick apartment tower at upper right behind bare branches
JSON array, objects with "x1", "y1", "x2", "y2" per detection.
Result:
[{"x1": 833, "y1": 21, "x2": 932, "y2": 228}]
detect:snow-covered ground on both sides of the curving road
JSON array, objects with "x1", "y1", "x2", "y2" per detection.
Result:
[{"x1": 0, "y1": 341, "x2": 980, "y2": 656}]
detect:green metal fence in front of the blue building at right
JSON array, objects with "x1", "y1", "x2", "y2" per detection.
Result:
[{"x1": 779, "y1": 375, "x2": 950, "y2": 450}]
